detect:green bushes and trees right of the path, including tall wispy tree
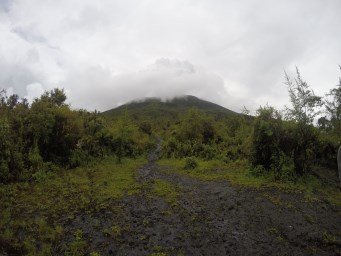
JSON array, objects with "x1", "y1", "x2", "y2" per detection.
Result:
[{"x1": 164, "y1": 69, "x2": 341, "y2": 181}]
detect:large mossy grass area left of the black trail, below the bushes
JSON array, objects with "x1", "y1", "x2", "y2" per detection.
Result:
[{"x1": 0, "y1": 158, "x2": 146, "y2": 255}]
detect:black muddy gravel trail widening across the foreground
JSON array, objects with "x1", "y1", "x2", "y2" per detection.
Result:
[{"x1": 59, "y1": 143, "x2": 341, "y2": 255}]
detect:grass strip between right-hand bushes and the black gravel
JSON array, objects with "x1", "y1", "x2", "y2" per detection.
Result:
[{"x1": 158, "y1": 159, "x2": 341, "y2": 206}]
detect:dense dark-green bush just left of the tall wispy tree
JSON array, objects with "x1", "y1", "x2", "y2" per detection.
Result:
[{"x1": 251, "y1": 103, "x2": 318, "y2": 177}]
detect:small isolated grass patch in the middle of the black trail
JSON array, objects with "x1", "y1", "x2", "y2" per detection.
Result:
[{"x1": 153, "y1": 179, "x2": 179, "y2": 207}]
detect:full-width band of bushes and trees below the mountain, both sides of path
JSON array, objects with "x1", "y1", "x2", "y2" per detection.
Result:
[{"x1": 0, "y1": 69, "x2": 341, "y2": 183}]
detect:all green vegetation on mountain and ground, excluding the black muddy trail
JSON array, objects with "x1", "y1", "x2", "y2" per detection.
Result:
[{"x1": 0, "y1": 66, "x2": 341, "y2": 255}]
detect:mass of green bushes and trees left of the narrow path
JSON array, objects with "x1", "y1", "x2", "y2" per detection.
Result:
[{"x1": 0, "y1": 89, "x2": 150, "y2": 183}]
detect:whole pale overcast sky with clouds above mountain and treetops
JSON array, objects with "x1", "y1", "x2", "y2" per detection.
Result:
[{"x1": 0, "y1": 0, "x2": 341, "y2": 111}]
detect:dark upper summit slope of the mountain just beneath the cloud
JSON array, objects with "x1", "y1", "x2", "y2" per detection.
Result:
[{"x1": 102, "y1": 95, "x2": 238, "y2": 119}]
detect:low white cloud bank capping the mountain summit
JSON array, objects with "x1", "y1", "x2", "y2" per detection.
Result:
[{"x1": 64, "y1": 58, "x2": 225, "y2": 110}]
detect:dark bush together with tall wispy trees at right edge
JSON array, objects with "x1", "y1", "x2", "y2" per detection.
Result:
[{"x1": 247, "y1": 69, "x2": 340, "y2": 176}]
